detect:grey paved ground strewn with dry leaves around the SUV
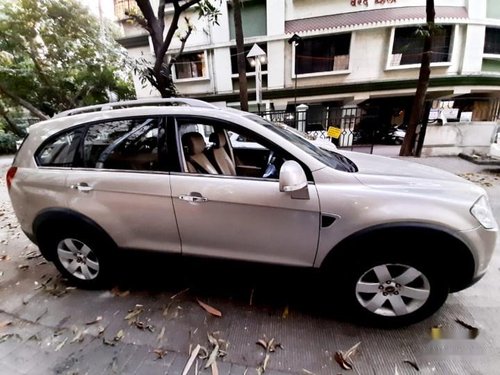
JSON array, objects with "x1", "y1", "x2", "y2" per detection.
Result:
[{"x1": 0, "y1": 154, "x2": 500, "y2": 375}]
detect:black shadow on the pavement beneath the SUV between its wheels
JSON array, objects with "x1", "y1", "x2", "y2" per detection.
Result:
[{"x1": 112, "y1": 252, "x2": 345, "y2": 320}]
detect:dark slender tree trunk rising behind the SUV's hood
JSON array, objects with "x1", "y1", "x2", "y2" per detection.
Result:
[{"x1": 399, "y1": 0, "x2": 436, "y2": 156}]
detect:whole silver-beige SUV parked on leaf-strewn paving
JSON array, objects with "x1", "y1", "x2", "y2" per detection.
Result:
[{"x1": 7, "y1": 99, "x2": 498, "y2": 326}]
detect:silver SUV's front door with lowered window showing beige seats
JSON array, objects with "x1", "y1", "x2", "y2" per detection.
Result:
[{"x1": 171, "y1": 117, "x2": 320, "y2": 266}]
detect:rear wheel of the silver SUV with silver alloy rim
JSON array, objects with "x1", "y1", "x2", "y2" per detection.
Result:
[{"x1": 49, "y1": 232, "x2": 113, "y2": 289}]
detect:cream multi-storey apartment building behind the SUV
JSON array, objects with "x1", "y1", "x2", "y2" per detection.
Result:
[{"x1": 106, "y1": 0, "x2": 500, "y2": 154}]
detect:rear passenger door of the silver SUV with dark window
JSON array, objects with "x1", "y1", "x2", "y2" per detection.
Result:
[{"x1": 66, "y1": 117, "x2": 181, "y2": 252}]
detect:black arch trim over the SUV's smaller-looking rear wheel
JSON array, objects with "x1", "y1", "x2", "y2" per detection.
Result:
[{"x1": 33, "y1": 208, "x2": 116, "y2": 260}]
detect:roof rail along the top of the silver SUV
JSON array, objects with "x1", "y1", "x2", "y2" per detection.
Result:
[{"x1": 54, "y1": 98, "x2": 220, "y2": 117}]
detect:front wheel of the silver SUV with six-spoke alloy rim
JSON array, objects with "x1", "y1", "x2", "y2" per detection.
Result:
[{"x1": 337, "y1": 254, "x2": 448, "y2": 328}]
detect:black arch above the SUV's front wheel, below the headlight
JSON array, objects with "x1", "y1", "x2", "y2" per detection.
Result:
[{"x1": 320, "y1": 223, "x2": 476, "y2": 292}]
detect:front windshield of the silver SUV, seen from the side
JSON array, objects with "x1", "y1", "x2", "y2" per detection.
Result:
[{"x1": 246, "y1": 115, "x2": 358, "y2": 172}]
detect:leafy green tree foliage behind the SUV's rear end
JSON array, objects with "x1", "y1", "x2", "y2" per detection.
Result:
[{"x1": 0, "y1": 0, "x2": 134, "y2": 115}]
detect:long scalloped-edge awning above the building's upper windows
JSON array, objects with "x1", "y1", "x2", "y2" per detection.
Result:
[{"x1": 285, "y1": 6, "x2": 468, "y2": 34}]
